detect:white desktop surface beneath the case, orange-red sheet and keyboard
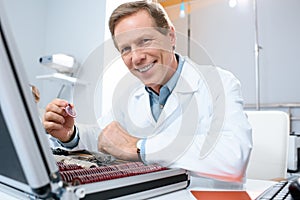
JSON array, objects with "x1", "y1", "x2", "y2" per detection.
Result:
[{"x1": 0, "y1": 179, "x2": 276, "y2": 200}]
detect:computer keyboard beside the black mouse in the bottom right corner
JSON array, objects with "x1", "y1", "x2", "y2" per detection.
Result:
[{"x1": 256, "y1": 180, "x2": 293, "y2": 200}]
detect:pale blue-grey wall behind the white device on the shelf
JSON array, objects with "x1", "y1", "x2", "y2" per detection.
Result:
[{"x1": 1, "y1": 0, "x2": 106, "y2": 121}]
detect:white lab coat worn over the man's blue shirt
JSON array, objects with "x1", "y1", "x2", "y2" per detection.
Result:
[{"x1": 63, "y1": 58, "x2": 252, "y2": 187}]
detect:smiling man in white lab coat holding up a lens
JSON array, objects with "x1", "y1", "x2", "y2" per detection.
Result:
[{"x1": 44, "y1": 1, "x2": 252, "y2": 186}]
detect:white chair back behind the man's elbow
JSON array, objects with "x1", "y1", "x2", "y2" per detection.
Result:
[{"x1": 246, "y1": 111, "x2": 290, "y2": 180}]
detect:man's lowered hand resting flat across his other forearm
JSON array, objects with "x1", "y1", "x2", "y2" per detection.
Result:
[{"x1": 98, "y1": 121, "x2": 139, "y2": 161}]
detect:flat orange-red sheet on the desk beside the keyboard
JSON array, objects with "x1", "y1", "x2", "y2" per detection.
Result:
[{"x1": 191, "y1": 190, "x2": 251, "y2": 200}]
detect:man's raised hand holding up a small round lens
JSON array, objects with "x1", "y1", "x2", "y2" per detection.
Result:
[{"x1": 43, "y1": 99, "x2": 75, "y2": 142}]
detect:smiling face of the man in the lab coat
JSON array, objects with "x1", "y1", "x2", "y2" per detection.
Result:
[{"x1": 115, "y1": 10, "x2": 177, "y2": 92}]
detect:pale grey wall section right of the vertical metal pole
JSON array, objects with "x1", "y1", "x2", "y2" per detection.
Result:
[{"x1": 258, "y1": 0, "x2": 300, "y2": 102}]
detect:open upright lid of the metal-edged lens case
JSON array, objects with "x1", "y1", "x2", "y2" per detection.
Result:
[{"x1": 0, "y1": 1, "x2": 59, "y2": 197}]
